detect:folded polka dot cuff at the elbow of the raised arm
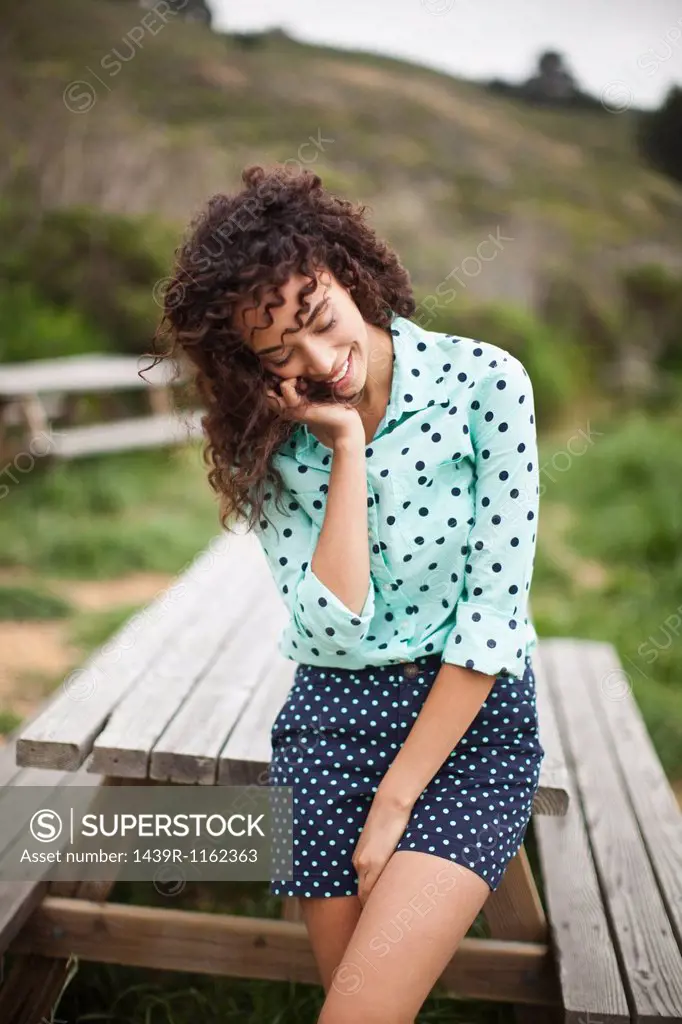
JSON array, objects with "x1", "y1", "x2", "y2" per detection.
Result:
[{"x1": 294, "y1": 566, "x2": 375, "y2": 647}]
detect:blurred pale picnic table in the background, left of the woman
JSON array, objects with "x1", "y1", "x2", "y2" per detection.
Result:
[{"x1": 0, "y1": 353, "x2": 201, "y2": 460}]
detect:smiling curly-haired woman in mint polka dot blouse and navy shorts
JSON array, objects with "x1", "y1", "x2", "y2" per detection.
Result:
[{"x1": 153, "y1": 166, "x2": 545, "y2": 1024}]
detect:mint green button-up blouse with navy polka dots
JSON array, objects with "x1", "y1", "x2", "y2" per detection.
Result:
[{"x1": 249, "y1": 315, "x2": 540, "y2": 678}]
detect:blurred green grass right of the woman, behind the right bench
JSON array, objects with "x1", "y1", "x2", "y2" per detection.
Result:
[{"x1": 532, "y1": 403, "x2": 682, "y2": 778}]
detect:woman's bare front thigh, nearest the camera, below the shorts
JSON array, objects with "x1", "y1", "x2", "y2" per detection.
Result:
[{"x1": 317, "y1": 850, "x2": 491, "y2": 1024}]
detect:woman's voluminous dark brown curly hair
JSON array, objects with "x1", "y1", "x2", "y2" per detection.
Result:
[{"x1": 147, "y1": 164, "x2": 415, "y2": 528}]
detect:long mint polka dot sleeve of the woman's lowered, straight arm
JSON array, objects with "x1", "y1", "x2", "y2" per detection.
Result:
[{"x1": 441, "y1": 353, "x2": 540, "y2": 677}]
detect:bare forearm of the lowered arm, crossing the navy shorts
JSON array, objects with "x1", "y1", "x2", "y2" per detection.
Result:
[{"x1": 375, "y1": 663, "x2": 496, "y2": 808}]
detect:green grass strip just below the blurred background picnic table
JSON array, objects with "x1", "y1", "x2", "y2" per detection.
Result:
[{"x1": 0, "y1": 445, "x2": 219, "y2": 580}]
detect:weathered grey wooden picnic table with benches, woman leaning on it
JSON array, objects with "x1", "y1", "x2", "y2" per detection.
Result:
[{"x1": 0, "y1": 529, "x2": 682, "y2": 1024}]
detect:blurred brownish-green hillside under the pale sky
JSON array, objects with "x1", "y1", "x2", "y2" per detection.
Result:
[{"x1": 5, "y1": 0, "x2": 682, "y2": 301}]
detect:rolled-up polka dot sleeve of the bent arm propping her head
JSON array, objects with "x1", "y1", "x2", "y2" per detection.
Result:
[{"x1": 255, "y1": 492, "x2": 375, "y2": 655}]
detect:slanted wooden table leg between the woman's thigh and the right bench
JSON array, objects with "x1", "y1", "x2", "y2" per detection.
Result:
[{"x1": 483, "y1": 845, "x2": 563, "y2": 1024}]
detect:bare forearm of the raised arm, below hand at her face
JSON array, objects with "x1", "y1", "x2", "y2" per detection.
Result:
[{"x1": 310, "y1": 435, "x2": 370, "y2": 612}]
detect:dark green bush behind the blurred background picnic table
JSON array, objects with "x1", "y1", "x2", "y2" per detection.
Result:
[{"x1": 0, "y1": 205, "x2": 176, "y2": 358}]
